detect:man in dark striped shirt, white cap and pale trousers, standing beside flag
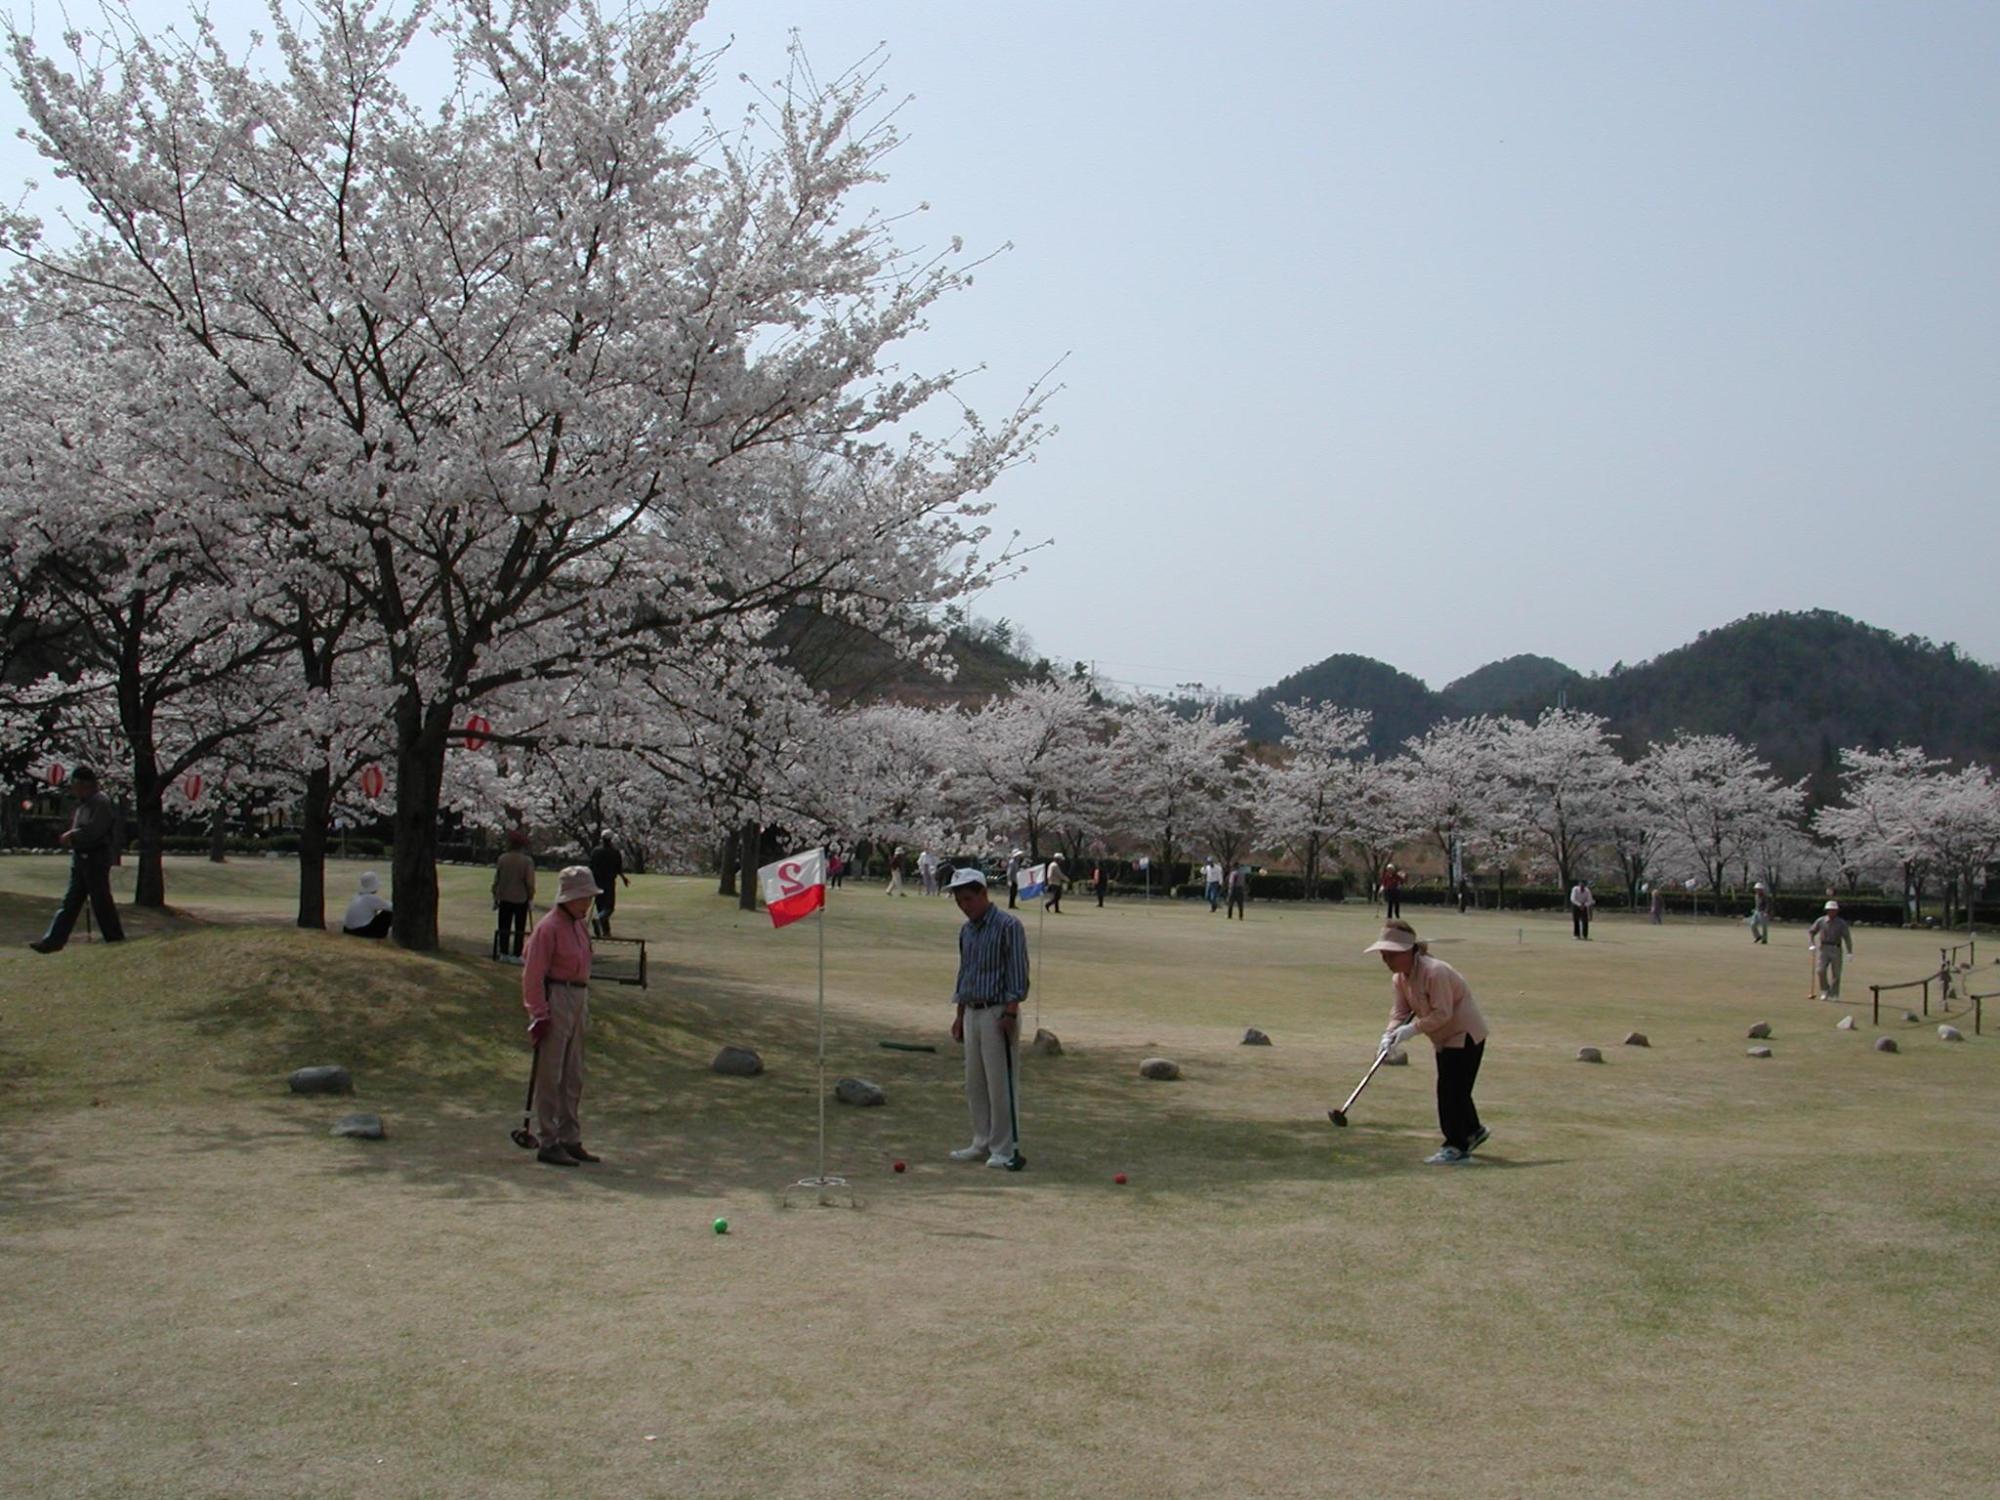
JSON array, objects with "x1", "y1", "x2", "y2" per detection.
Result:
[{"x1": 950, "y1": 866, "x2": 1028, "y2": 1172}]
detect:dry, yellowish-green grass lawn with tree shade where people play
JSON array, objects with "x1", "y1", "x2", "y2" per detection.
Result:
[{"x1": 0, "y1": 858, "x2": 2000, "y2": 1500}]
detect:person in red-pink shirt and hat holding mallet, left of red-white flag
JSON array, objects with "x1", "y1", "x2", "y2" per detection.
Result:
[{"x1": 520, "y1": 864, "x2": 602, "y2": 1166}]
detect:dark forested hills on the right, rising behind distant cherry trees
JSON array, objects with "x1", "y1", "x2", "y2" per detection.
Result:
[{"x1": 1238, "y1": 610, "x2": 2000, "y2": 796}]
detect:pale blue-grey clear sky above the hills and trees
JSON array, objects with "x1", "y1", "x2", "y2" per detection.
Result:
[{"x1": 4, "y1": 0, "x2": 2000, "y2": 692}]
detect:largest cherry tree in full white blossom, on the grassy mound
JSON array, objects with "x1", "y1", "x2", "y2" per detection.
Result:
[{"x1": 6, "y1": 0, "x2": 1040, "y2": 948}]
